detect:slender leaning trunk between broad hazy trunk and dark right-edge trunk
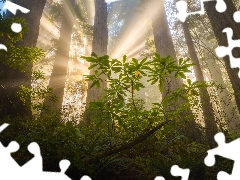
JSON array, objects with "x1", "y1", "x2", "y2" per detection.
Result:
[{"x1": 182, "y1": 22, "x2": 218, "y2": 147}]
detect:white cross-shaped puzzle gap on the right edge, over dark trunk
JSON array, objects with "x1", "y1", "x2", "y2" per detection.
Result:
[{"x1": 215, "y1": 28, "x2": 240, "y2": 78}]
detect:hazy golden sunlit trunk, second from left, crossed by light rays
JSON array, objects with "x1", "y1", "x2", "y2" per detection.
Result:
[{"x1": 45, "y1": 0, "x2": 75, "y2": 109}]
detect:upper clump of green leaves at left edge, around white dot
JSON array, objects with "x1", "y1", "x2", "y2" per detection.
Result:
[{"x1": 0, "y1": 16, "x2": 44, "y2": 72}]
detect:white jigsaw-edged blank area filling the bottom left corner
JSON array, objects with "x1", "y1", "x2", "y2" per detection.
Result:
[{"x1": 0, "y1": 123, "x2": 91, "y2": 180}]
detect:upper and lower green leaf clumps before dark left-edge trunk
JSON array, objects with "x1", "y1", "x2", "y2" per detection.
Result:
[{"x1": 0, "y1": 15, "x2": 56, "y2": 115}]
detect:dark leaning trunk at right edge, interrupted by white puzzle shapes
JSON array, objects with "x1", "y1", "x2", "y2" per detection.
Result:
[{"x1": 204, "y1": 0, "x2": 240, "y2": 112}]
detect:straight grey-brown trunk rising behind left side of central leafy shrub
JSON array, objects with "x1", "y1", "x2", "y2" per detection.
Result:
[{"x1": 85, "y1": 0, "x2": 108, "y2": 123}]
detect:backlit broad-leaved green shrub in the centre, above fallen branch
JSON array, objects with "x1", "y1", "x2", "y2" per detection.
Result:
[{"x1": 82, "y1": 54, "x2": 206, "y2": 134}]
